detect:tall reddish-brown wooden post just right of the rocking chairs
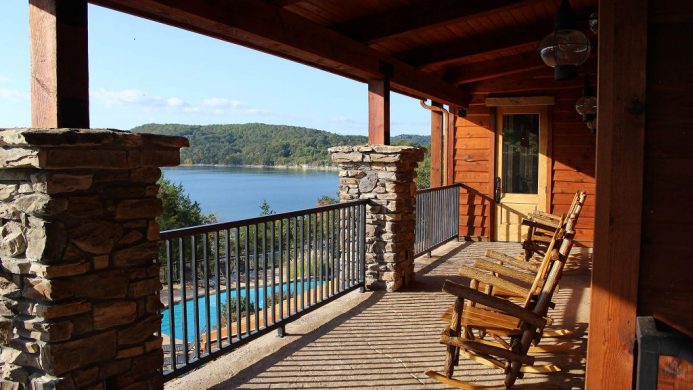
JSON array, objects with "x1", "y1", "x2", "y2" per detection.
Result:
[{"x1": 585, "y1": 0, "x2": 649, "y2": 389}]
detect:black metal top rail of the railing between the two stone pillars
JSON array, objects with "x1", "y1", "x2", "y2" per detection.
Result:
[{"x1": 160, "y1": 199, "x2": 369, "y2": 240}]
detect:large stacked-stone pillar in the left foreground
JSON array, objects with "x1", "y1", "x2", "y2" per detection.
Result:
[{"x1": 0, "y1": 129, "x2": 187, "y2": 389}]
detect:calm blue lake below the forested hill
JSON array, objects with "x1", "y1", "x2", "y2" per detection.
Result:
[{"x1": 163, "y1": 167, "x2": 339, "y2": 222}]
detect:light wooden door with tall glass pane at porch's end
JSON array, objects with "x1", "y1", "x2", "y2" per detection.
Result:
[{"x1": 494, "y1": 106, "x2": 549, "y2": 242}]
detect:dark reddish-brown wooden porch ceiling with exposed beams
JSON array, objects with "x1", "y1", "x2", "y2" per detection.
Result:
[{"x1": 90, "y1": 0, "x2": 597, "y2": 105}]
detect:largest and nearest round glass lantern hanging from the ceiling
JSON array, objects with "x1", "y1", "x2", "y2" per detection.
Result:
[{"x1": 539, "y1": 0, "x2": 591, "y2": 80}]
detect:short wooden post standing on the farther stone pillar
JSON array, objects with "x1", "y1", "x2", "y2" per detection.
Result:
[{"x1": 368, "y1": 78, "x2": 390, "y2": 145}]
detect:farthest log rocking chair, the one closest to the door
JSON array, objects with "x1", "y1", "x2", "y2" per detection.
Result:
[{"x1": 522, "y1": 191, "x2": 586, "y2": 261}]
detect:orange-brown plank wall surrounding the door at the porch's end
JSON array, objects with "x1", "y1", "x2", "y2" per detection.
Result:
[{"x1": 454, "y1": 66, "x2": 596, "y2": 246}]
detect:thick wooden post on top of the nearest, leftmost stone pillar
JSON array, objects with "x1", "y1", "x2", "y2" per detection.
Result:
[{"x1": 29, "y1": 0, "x2": 89, "y2": 129}]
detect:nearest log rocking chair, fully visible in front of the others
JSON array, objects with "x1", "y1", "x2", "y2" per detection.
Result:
[{"x1": 426, "y1": 203, "x2": 576, "y2": 389}]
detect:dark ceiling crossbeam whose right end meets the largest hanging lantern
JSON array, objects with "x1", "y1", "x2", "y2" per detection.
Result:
[{"x1": 397, "y1": 19, "x2": 552, "y2": 70}]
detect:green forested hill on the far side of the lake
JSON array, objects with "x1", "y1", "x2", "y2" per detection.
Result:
[{"x1": 131, "y1": 123, "x2": 430, "y2": 166}]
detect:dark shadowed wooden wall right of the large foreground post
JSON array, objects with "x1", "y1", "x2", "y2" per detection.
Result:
[{"x1": 637, "y1": 0, "x2": 693, "y2": 331}]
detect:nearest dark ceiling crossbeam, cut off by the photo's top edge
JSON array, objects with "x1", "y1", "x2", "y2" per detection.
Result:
[{"x1": 332, "y1": 0, "x2": 524, "y2": 45}]
